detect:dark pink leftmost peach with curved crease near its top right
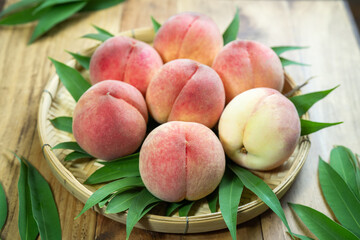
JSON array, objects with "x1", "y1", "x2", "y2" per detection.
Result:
[{"x1": 73, "y1": 80, "x2": 148, "y2": 160}]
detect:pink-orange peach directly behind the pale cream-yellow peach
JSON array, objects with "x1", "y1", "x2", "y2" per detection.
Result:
[{"x1": 212, "y1": 40, "x2": 284, "y2": 103}]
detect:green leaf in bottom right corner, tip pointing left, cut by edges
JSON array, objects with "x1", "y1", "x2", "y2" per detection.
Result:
[{"x1": 289, "y1": 203, "x2": 358, "y2": 240}]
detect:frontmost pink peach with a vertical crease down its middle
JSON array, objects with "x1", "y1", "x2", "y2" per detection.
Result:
[{"x1": 139, "y1": 121, "x2": 225, "y2": 202}]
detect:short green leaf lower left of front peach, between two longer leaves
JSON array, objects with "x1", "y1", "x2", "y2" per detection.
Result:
[{"x1": 105, "y1": 189, "x2": 139, "y2": 213}]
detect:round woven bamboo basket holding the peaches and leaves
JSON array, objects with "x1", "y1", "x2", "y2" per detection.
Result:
[{"x1": 38, "y1": 28, "x2": 310, "y2": 233}]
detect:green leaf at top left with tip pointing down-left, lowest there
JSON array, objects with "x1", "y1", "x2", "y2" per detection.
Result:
[{"x1": 29, "y1": 2, "x2": 86, "y2": 44}]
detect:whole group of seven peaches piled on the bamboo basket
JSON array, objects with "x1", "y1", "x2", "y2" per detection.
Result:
[{"x1": 73, "y1": 13, "x2": 300, "y2": 202}]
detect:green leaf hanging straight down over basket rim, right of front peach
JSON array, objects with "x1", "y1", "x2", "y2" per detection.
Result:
[{"x1": 219, "y1": 168, "x2": 244, "y2": 239}]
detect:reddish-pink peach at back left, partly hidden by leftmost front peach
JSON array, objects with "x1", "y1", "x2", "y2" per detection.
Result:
[{"x1": 90, "y1": 36, "x2": 163, "y2": 96}]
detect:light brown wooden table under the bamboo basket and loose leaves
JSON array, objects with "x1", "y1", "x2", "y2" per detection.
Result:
[{"x1": 0, "y1": 0, "x2": 360, "y2": 239}]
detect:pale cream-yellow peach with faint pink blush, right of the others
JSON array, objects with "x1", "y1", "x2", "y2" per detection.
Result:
[{"x1": 219, "y1": 88, "x2": 300, "y2": 170}]
